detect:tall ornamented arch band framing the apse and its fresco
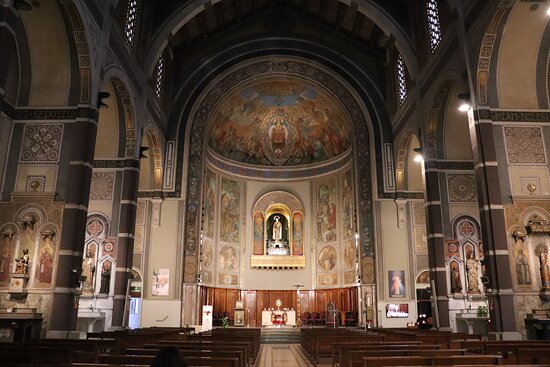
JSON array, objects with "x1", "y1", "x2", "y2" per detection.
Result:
[{"x1": 185, "y1": 57, "x2": 375, "y2": 283}]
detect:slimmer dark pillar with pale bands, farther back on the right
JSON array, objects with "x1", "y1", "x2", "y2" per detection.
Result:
[{"x1": 424, "y1": 157, "x2": 451, "y2": 330}]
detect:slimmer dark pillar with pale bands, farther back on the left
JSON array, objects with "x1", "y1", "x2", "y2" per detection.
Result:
[{"x1": 112, "y1": 159, "x2": 139, "y2": 327}]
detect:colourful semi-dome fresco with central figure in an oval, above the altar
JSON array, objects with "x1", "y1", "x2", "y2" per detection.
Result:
[{"x1": 209, "y1": 75, "x2": 351, "y2": 166}]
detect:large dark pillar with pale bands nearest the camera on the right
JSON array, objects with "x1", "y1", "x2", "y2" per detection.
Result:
[{"x1": 468, "y1": 107, "x2": 521, "y2": 339}]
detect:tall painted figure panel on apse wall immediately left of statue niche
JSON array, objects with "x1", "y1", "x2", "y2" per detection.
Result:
[{"x1": 220, "y1": 178, "x2": 241, "y2": 243}]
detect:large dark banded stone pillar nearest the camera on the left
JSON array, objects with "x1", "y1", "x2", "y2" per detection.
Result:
[{"x1": 50, "y1": 110, "x2": 97, "y2": 337}]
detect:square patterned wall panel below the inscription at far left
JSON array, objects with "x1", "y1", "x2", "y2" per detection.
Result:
[{"x1": 20, "y1": 124, "x2": 63, "y2": 163}]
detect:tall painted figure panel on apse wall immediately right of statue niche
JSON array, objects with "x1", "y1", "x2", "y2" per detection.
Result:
[{"x1": 316, "y1": 178, "x2": 337, "y2": 242}]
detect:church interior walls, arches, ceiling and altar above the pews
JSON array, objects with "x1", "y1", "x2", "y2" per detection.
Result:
[{"x1": 0, "y1": 0, "x2": 550, "y2": 348}]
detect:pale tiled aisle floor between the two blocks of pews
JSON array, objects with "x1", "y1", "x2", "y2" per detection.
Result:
[{"x1": 254, "y1": 344, "x2": 330, "y2": 367}]
